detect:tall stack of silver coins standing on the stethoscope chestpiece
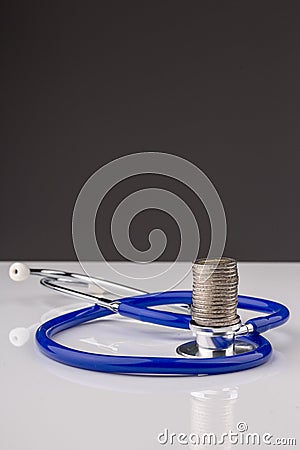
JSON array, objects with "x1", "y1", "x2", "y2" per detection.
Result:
[{"x1": 192, "y1": 258, "x2": 240, "y2": 328}]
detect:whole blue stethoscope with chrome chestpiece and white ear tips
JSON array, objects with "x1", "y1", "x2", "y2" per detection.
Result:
[{"x1": 9, "y1": 263, "x2": 289, "y2": 375}]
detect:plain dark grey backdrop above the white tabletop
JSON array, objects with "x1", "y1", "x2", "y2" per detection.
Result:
[{"x1": 0, "y1": 1, "x2": 300, "y2": 261}]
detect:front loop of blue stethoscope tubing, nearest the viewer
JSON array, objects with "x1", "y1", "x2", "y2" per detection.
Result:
[{"x1": 36, "y1": 305, "x2": 272, "y2": 375}]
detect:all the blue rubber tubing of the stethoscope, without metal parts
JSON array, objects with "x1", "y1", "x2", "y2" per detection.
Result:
[{"x1": 36, "y1": 291, "x2": 289, "y2": 375}]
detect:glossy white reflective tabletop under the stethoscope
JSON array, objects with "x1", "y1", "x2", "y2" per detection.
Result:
[{"x1": 0, "y1": 263, "x2": 300, "y2": 450}]
